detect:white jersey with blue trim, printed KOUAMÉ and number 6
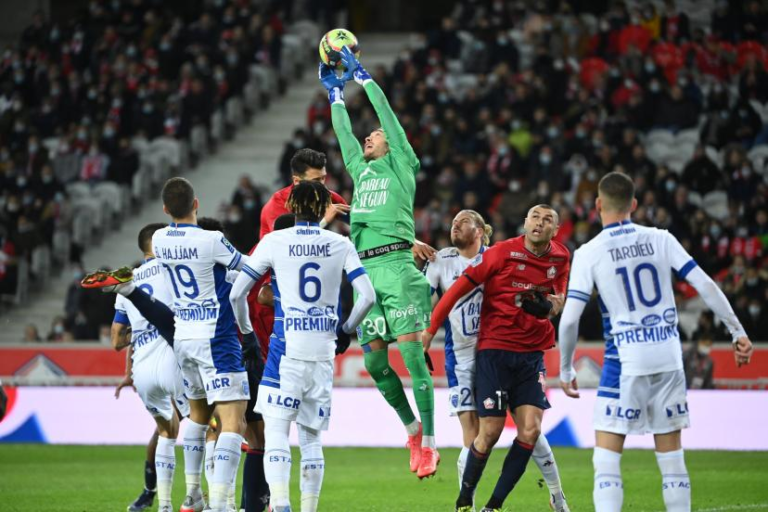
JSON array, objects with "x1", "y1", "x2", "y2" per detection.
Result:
[{"x1": 241, "y1": 222, "x2": 365, "y2": 361}]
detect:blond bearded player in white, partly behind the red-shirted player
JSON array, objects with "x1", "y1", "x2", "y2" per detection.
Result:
[{"x1": 425, "y1": 210, "x2": 568, "y2": 512}]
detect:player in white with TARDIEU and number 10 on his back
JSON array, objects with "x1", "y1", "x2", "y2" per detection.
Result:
[{"x1": 560, "y1": 172, "x2": 752, "y2": 512}]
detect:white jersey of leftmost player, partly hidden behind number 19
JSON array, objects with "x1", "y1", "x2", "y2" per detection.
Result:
[{"x1": 115, "y1": 258, "x2": 173, "y2": 367}]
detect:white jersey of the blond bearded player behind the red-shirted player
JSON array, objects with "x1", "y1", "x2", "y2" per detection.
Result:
[{"x1": 424, "y1": 247, "x2": 485, "y2": 368}]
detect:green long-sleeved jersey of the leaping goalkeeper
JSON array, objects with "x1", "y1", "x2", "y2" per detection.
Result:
[{"x1": 331, "y1": 81, "x2": 419, "y2": 254}]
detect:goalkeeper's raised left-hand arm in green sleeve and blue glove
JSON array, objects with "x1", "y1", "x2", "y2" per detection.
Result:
[{"x1": 318, "y1": 62, "x2": 365, "y2": 177}]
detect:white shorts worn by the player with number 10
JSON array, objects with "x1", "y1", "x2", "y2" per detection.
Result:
[{"x1": 594, "y1": 370, "x2": 690, "y2": 435}]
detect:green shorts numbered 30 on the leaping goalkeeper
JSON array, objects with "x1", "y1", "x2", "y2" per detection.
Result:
[{"x1": 355, "y1": 255, "x2": 432, "y2": 345}]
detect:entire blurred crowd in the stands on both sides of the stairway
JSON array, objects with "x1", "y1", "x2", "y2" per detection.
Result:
[{"x1": 6, "y1": 0, "x2": 768, "y2": 348}]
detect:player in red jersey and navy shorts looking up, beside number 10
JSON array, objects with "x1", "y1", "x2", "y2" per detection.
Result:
[{"x1": 422, "y1": 204, "x2": 570, "y2": 512}]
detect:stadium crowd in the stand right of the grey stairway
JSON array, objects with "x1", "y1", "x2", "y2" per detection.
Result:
[{"x1": 272, "y1": 0, "x2": 768, "y2": 341}]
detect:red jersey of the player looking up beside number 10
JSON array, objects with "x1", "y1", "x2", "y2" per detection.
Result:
[{"x1": 464, "y1": 236, "x2": 570, "y2": 352}]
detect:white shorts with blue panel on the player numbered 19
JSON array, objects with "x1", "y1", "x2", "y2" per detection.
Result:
[{"x1": 173, "y1": 337, "x2": 250, "y2": 405}]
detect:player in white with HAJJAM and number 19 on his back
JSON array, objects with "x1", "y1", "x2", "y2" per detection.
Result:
[{"x1": 152, "y1": 178, "x2": 252, "y2": 512}]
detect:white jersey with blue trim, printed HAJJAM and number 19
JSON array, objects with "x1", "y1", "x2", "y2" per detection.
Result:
[{"x1": 152, "y1": 223, "x2": 242, "y2": 340}]
